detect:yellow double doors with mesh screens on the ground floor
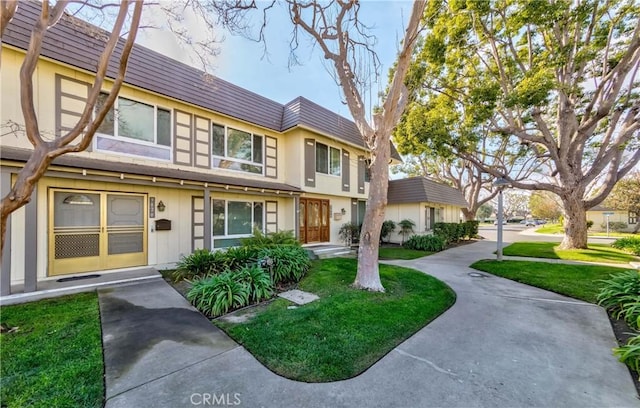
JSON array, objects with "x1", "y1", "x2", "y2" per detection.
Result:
[{"x1": 49, "y1": 189, "x2": 147, "y2": 275}]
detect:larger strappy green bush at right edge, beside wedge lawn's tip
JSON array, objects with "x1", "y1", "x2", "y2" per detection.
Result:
[{"x1": 596, "y1": 271, "x2": 640, "y2": 330}]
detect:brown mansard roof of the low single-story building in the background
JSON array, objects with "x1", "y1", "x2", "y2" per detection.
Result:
[{"x1": 387, "y1": 177, "x2": 468, "y2": 207}]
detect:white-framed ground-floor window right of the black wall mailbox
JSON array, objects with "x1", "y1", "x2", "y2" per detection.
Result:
[{"x1": 211, "y1": 199, "x2": 264, "y2": 237}]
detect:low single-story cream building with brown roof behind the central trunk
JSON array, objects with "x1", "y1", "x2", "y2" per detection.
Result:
[{"x1": 385, "y1": 177, "x2": 468, "y2": 242}]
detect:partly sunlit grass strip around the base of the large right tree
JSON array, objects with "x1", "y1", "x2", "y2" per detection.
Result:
[{"x1": 503, "y1": 242, "x2": 640, "y2": 264}]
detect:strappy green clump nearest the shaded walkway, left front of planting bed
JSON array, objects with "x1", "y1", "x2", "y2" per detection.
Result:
[{"x1": 187, "y1": 271, "x2": 249, "y2": 316}]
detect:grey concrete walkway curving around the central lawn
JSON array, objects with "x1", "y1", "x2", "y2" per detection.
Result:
[{"x1": 99, "y1": 242, "x2": 640, "y2": 408}]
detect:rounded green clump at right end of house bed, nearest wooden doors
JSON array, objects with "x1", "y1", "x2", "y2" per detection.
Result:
[{"x1": 258, "y1": 245, "x2": 311, "y2": 284}]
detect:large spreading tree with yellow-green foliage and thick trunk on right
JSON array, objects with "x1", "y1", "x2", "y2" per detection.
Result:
[{"x1": 402, "y1": 0, "x2": 640, "y2": 248}]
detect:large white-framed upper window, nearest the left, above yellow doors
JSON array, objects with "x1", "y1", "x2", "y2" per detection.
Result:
[{"x1": 95, "y1": 93, "x2": 172, "y2": 160}]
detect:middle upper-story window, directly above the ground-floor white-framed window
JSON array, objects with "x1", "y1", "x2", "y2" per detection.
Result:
[{"x1": 211, "y1": 124, "x2": 264, "y2": 174}]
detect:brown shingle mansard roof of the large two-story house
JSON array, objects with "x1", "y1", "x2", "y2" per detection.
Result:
[{"x1": 2, "y1": 1, "x2": 400, "y2": 159}]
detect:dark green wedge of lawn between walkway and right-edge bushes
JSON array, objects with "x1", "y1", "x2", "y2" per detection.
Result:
[{"x1": 471, "y1": 260, "x2": 624, "y2": 303}]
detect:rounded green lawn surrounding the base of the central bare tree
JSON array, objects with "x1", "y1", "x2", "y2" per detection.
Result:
[{"x1": 216, "y1": 258, "x2": 455, "y2": 382}]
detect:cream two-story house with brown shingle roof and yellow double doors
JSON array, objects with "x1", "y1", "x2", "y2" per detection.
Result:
[{"x1": 0, "y1": 2, "x2": 399, "y2": 295}]
